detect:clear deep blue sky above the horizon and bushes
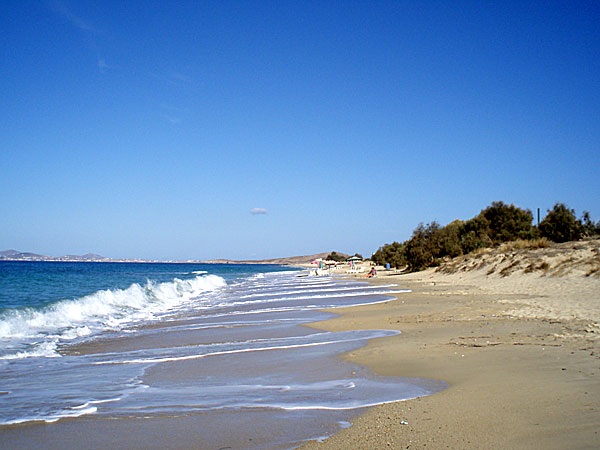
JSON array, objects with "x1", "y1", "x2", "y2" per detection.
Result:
[{"x1": 0, "y1": 0, "x2": 600, "y2": 259}]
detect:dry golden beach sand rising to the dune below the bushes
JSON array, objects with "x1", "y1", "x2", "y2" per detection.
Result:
[{"x1": 303, "y1": 241, "x2": 600, "y2": 449}]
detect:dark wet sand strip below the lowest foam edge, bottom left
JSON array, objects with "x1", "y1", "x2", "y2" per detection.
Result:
[{"x1": 0, "y1": 410, "x2": 339, "y2": 450}]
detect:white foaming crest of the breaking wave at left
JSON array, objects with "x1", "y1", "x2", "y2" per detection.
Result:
[{"x1": 0, "y1": 275, "x2": 226, "y2": 359}]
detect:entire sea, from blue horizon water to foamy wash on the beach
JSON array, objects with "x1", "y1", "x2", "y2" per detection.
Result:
[{"x1": 0, "y1": 261, "x2": 445, "y2": 449}]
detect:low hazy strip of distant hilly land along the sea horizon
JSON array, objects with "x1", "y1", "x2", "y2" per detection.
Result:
[{"x1": 0, "y1": 250, "x2": 330, "y2": 265}]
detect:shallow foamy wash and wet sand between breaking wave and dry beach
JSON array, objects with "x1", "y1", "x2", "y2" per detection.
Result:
[{"x1": 0, "y1": 269, "x2": 418, "y2": 450}]
